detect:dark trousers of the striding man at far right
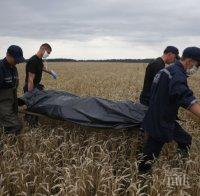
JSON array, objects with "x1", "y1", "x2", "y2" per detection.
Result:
[{"x1": 138, "y1": 123, "x2": 192, "y2": 173}]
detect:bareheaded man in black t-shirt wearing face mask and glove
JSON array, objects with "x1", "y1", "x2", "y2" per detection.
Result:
[{"x1": 24, "y1": 43, "x2": 57, "y2": 126}]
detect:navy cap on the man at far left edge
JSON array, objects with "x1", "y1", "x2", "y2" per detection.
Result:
[{"x1": 7, "y1": 45, "x2": 25, "y2": 63}]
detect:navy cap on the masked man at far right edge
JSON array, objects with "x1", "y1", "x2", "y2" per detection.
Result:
[{"x1": 183, "y1": 46, "x2": 200, "y2": 65}]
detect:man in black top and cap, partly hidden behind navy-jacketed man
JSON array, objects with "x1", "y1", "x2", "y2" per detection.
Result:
[{"x1": 140, "y1": 46, "x2": 180, "y2": 106}]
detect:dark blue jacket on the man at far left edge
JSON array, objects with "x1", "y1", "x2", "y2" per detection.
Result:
[{"x1": 0, "y1": 58, "x2": 18, "y2": 90}]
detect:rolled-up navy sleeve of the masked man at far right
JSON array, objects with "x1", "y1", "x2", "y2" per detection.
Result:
[{"x1": 169, "y1": 81, "x2": 197, "y2": 109}]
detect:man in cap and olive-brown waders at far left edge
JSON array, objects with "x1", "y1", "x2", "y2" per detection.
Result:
[{"x1": 0, "y1": 45, "x2": 25, "y2": 134}]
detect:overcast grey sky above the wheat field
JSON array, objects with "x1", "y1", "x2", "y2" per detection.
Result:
[{"x1": 0, "y1": 0, "x2": 200, "y2": 59}]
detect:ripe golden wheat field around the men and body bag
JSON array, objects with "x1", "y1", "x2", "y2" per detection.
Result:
[{"x1": 0, "y1": 62, "x2": 200, "y2": 196}]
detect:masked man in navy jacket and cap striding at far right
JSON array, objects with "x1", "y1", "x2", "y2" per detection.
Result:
[{"x1": 139, "y1": 47, "x2": 200, "y2": 172}]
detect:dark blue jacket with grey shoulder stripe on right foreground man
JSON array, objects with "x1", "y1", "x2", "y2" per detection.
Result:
[{"x1": 142, "y1": 62, "x2": 197, "y2": 142}]
